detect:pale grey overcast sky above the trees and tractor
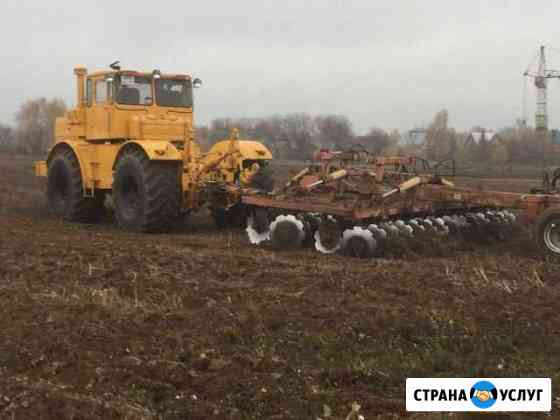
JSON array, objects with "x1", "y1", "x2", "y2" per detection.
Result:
[{"x1": 0, "y1": 0, "x2": 560, "y2": 133}]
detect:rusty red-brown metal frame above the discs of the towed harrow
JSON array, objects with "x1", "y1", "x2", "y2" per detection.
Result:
[{"x1": 241, "y1": 151, "x2": 560, "y2": 225}]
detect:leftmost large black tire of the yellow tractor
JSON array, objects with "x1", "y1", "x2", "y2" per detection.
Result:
[{"x1": 47, "y1": 148, "x2": 105, "y2": 223}]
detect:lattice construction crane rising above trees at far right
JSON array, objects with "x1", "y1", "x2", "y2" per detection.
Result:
[{"x1": 523, "y1": 45, "x2": 560, "y2": 132}]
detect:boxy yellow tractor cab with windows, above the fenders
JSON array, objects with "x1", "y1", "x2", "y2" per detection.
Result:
[{"x1": 66, "y1": 68, "x2": 201, "y2": 142}]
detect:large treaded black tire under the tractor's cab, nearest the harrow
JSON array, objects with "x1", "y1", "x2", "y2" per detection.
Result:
[{"x1": 113, "y1": 149, "x2": 181, "y2": 233}]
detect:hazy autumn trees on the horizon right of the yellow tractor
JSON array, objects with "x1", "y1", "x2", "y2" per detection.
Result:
[{"x1": 197, "y1": 109, "x2": 550, "y2": 171}]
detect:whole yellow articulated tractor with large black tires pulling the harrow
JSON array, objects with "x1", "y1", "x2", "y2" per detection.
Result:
[{"x1": 35, "y1": 63, "x2": 272, "y2": 232}]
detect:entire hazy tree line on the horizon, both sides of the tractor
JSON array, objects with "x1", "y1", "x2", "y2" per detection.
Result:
[{"x1": 0, "y1": 98, "x2": 543, "y2": 167}]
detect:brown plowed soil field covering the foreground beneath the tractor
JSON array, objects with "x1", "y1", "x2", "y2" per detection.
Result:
[{"x1": 0, "y1": 156, "x2": 560, "y2": 420}]
